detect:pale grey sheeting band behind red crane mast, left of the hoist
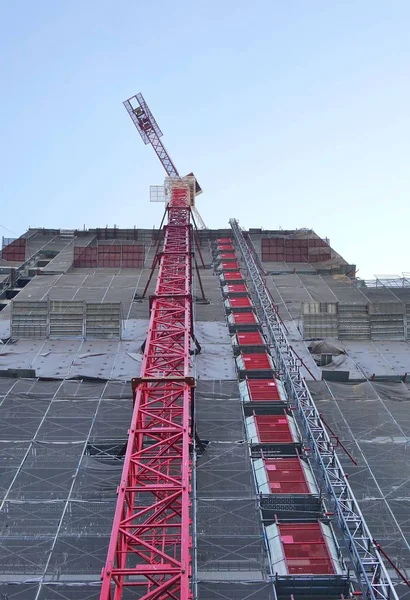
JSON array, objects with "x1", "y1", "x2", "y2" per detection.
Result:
[{"x1": 0, "y1": 319, "x2": 235, "y2": 381}]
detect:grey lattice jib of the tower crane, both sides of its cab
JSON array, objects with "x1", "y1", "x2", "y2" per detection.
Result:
[{"x1": 123, "y1": 94, "x2": 207, "y2": 229}]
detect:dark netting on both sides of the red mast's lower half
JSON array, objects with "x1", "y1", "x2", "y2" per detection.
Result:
[{"x1": 0, "y1": 378, "x2": 272, "y2": 600}]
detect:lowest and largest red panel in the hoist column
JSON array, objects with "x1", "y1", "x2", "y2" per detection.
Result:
[{"x1": 279, "y1": 523, "x2": 335, "y2": 575}]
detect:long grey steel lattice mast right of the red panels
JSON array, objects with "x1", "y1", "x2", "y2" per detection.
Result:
[{"x1": 230, "y1": 219, "x2": 398, "y2": 600}]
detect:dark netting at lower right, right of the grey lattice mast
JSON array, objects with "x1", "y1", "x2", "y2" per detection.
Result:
[{"x1": 308, "y1": 381, "x2": 410, "y2": 580}]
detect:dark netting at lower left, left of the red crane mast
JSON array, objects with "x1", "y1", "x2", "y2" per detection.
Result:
[{"x1": 0, "y1": 378, "x2": 131, "y2": 600}]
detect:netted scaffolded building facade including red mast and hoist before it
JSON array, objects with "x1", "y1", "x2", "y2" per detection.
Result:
[{"x1": 0, "y1": 218, "x2": 410, "y2": 600}]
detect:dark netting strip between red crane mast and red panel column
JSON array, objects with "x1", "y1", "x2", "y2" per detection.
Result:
[{"x1": 195, "y1": 380, "x2": 272, "y2": 584}]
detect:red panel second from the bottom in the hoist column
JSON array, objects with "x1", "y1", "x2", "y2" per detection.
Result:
[{"x1": 264, "y1": 458, "x2": 310, "y2": 494}]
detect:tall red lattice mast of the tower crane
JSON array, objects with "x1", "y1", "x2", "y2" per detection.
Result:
[{"x1": 100, "y1": 182, "x2": 193, "y2": 600}]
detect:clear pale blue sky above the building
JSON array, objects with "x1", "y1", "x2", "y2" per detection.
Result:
[{"x1": 0, "y1": 0, "x2": 410, "y2": 278}]
